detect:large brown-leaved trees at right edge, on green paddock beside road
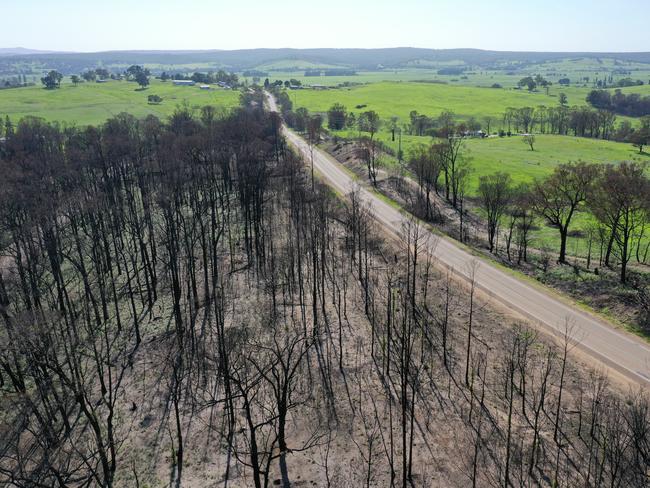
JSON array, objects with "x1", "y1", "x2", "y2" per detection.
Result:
[{"x1": 470, "y1": 162, "x2": 650, "y2": 283}]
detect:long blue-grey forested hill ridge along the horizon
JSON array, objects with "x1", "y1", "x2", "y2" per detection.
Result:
[{"x1": 0, "y1": 47, "x2": 650, "y2": 74}]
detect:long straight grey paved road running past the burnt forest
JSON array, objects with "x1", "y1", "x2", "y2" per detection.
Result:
[{"x1": 268, "y1": 93, "x2": 650, "y2": 387}]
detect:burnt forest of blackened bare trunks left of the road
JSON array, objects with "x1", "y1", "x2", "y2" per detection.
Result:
[{"x1": 0, "y1": 92, "x2": 650, "y2": 488}]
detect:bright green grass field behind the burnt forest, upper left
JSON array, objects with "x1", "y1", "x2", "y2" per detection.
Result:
[{"x1": 0, "y1": 79, "x2": 239, "y2": 125}]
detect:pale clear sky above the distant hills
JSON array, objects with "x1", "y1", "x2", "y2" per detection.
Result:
[{"x1": 0, "y1": 0, "x2": 650, "y2": 52}]
